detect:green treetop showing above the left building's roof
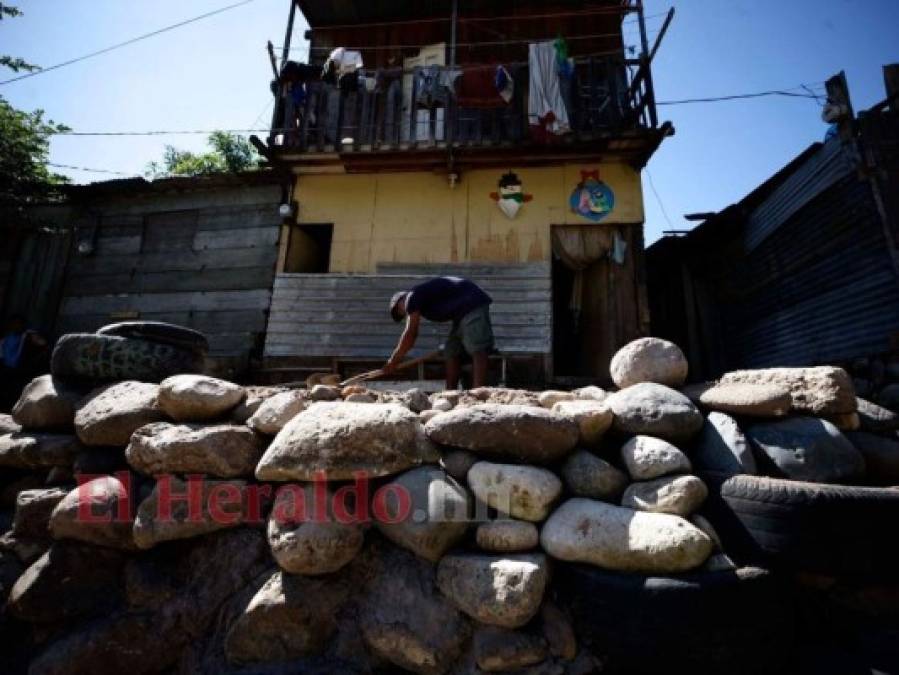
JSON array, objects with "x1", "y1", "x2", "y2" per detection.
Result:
[{"x1": 146, "y1": 131, "x2": 259, "y2": 178}]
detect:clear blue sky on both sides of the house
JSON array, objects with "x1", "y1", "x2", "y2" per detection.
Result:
[{"x1": 0, "y1": 0, "x2": 899, "y2": 244}]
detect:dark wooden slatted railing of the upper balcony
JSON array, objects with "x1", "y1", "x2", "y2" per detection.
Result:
[{"x1": 269, "y1": 56, "x2": 657, "y2": 154}]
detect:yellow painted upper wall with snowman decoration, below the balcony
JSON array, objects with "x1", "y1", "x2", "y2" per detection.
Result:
[{"x1": 295, "y1": 164, "x2": 643, "y2": 273}]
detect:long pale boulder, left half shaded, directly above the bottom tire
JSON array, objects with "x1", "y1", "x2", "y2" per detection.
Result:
[{"x1": 540, "y1": 498, "x2": 714, "y2": 573}]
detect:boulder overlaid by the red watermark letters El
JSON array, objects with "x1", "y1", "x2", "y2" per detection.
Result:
[{"x1": 50, "y1": 473, "x2": 134, "y2": 550}]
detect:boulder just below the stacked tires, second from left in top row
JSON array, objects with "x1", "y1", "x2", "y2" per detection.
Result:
[{"x1": 75, "y1": 381, "x2": 165, "y2": 447}]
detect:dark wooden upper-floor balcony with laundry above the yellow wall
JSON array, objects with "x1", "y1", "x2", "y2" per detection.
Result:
[{"x1": 268, "y1": 1, "x2": 670, "y2": 171}]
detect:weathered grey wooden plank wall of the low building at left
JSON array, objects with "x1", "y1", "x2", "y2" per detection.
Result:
[{"x1": 56, "y1": 186, "x2": 281, "y2": 370}]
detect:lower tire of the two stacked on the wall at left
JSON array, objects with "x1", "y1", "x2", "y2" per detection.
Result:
[{"x1": 50, "y1": 333, "x2": 203, "y2": 382}]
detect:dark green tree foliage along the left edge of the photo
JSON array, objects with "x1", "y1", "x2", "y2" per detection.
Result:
[{"x1": 0, "y1": 4, "x2": 69, "y2": 209}]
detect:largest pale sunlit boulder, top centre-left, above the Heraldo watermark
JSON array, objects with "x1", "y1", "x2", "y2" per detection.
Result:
[{"x1": 256, "y1": 402, "x2": 428, "y2": 481}]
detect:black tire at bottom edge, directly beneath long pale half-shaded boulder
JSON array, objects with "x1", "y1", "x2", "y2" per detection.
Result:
[{"x1": 554, "y1": 564, "x2": 794, "y2": 674}]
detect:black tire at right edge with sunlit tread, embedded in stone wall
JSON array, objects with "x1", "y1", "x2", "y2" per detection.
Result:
[{"x1": 721, "y1": 476, "x2": 899, "y2": 577}]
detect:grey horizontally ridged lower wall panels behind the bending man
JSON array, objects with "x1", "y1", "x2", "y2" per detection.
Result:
[{"x1": 265, "y1": 262, "x2": 552, "y2": 359}]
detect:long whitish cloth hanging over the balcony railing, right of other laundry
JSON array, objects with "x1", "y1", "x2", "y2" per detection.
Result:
[{"x1": 528, "y1": 42, "x2": 571, "y2": 142}]
